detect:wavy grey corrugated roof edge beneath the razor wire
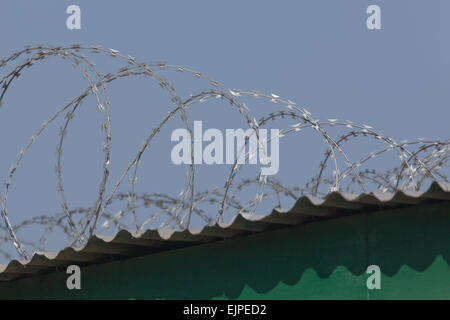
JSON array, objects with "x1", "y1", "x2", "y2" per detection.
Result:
[{"x1": 0, "y1": 181, "x2": 450, "y2": 281}]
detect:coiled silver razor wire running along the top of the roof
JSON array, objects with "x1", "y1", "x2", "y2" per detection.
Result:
[{"x1": 0, "y1": 45, "x2": 450, "y2": 259}]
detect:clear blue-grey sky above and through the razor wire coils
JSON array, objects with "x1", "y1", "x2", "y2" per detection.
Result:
[{"x1": 0, "y1": 0, "x2": 450, "y2": 260}]
